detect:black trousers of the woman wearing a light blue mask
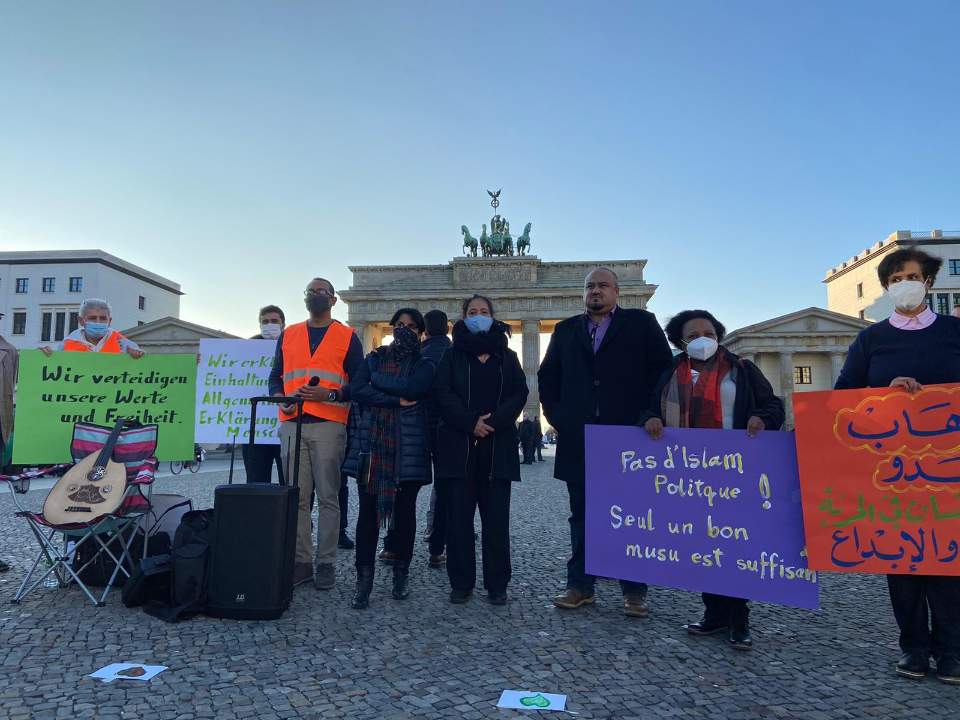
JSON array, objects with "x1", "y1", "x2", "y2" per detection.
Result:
[{"x1": 443, "y1": 447, "x2": 513, "y2": 592}]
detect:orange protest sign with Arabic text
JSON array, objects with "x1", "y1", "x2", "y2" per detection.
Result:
[{"x1": 793, "y1": 385, "x2": 960, "y2": 575}]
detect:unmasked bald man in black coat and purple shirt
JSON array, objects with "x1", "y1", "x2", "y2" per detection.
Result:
[{"x1": 537, "y1": 267, "x2": 672, "y2": 617}]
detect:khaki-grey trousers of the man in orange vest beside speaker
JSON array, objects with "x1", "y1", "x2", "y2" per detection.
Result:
[{"x1": 280, "y1": 421, "x2": 347, "y2": 565}]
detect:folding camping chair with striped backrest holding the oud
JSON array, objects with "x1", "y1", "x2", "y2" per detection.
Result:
[{"x1": 0, "y1": 423, "x2": 158, "y2": 607}]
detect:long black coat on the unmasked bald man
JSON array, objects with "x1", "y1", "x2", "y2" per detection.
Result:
[{"x1": 537, "y1": 307, "x2": 672, "y2": 483}]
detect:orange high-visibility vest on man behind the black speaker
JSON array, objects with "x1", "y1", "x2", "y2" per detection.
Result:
[{"x1": 278, "y1": 320, "x2": 353, "y2": 425}]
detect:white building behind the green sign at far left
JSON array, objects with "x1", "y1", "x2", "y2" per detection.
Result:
[{"x1": 0, "y1": 250, "x2": 183, "y2": 348}]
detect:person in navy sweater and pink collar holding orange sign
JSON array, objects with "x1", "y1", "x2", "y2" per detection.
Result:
[{"x1": 834, "y1": 248, "x2": 960, "y2": 685}]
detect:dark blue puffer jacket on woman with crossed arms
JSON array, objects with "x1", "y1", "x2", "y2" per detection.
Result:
[{"x1": 341, "y1": 348, "x2": 436, "y2": 484}]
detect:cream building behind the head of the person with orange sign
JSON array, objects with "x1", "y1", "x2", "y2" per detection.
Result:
[{"x1": 823, "y1": 230, "x2": 960, "y2": 322}]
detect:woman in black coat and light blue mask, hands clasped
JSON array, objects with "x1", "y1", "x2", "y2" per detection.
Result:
[{"x1": 434, "y1": 295, "x2": 528, "y2": 605}]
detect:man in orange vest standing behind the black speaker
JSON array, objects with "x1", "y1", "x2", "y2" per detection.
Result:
[{"x1": 269, "y1": 278, "x2": 363, "y2": 590}]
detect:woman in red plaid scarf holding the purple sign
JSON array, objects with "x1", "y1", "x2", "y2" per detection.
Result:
[{"x1": 643, "y1": 310, "x2": 784, "y2": 650}]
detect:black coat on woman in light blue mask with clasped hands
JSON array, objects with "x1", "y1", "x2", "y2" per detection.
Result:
[{"x1": 434, "y1": 330, "x2": 529, "y2": 482}]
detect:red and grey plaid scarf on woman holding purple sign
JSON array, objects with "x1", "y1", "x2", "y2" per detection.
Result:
[{"x1": 660, "y1": 349, "x2": 733, "y2": 428}]
